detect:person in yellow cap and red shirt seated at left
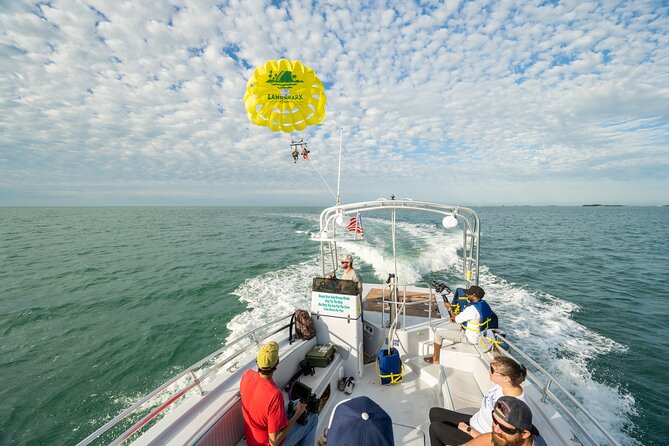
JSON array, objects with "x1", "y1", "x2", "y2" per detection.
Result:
[{"x1": 239, "y1": 341, "x2": 318, "y2": 446}]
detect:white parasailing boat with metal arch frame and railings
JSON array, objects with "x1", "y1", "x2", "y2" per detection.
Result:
[{"x1": 79, "y1": 197, "x2": 619, "y2": 446}]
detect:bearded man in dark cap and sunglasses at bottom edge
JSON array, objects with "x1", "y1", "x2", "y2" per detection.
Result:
[{"x1": 460, "y1": 396, "x2": 546, "y2": 446}]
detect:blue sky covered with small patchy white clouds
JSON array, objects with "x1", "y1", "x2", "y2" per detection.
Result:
[{"x1": 0, "y1": 0, "x2": 669, "y2": 206}]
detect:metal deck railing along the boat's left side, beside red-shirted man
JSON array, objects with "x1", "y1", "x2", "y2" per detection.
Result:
[{"x1": 77, "y1": 313, "x2": 292, "y2": 446}]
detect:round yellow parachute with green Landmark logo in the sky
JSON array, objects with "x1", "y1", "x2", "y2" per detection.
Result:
[{"x1": 244, "y1": 59, "x2": 326, "y2": 133}]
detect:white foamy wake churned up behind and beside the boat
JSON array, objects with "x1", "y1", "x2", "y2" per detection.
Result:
[{"x1": 228, "y1": 218, "x2": 639, "y2": 444}]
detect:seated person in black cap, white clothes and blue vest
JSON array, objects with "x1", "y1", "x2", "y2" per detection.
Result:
[{"x1": 423, "y1": 285, "x2": 494, "y2": 364}]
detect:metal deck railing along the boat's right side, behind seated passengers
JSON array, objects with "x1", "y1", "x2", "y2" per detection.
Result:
[{"x1": 497, "y1": 334, "x2": 621, "y2": 446}]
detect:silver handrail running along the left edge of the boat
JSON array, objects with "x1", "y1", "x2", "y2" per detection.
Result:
[{"x1": 77, "y1": 313, "x2": 292, "y2": 446}]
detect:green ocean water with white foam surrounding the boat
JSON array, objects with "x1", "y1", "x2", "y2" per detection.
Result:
[{"x1": 0, "y1": 206, "x2": 669, "y2": 445}]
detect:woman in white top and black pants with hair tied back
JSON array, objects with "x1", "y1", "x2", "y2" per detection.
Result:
[{"x1": 430, "y1": 356, "x2": 527, "y2": 446}]
